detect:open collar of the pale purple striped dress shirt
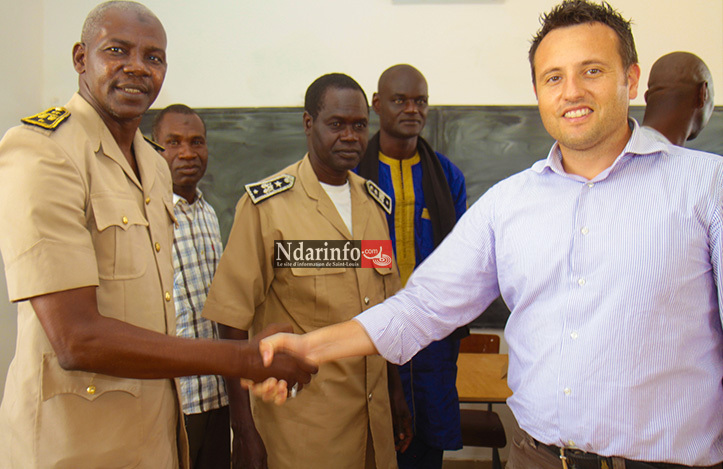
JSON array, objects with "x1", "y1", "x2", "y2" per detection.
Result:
[{"x1": 532, "y1": 118, "x2": 666, "y2": 182}]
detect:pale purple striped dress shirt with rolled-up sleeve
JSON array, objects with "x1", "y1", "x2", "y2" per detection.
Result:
[{"x1": 356, "y1": 121, "x2": 723, "y2": 465}]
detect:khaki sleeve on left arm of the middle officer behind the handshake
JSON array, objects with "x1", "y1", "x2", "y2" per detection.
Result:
[{"x1": 203, "y1": 195, "x2": 274, "y2": 330}]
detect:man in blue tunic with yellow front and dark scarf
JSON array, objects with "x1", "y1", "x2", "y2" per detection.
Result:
[{"x1": 357, "y1": 64, "x2": 467, "y2": 469}]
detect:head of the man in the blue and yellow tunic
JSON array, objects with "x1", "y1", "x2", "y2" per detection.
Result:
[{"x1": 372, "y1": 66, "x2": 428, "y2": 139}]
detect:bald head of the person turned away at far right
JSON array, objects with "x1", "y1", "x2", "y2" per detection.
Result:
[{"x1": 643, "y1": 52, "x2": 713, "y2": 146}]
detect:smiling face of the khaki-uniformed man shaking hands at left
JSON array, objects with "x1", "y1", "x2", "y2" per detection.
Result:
[{"x1": 73, "y1": 9, "x2": 166, "y2": 126}]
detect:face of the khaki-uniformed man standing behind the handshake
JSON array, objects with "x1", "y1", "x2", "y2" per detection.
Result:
[{"x1": 304, "y1": 88, "x2": 369, "y2": 185}]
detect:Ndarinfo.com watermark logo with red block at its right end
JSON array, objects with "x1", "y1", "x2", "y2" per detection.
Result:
[{"x1": 274, "y1": 240, "x2": 392, "y2": 268}]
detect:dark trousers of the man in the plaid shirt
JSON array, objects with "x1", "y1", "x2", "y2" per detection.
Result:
[{"x1": 184, "y1": 406, "x2": 231, "y2": 469}]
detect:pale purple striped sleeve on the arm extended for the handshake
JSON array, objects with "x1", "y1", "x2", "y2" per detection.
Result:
[{"x1": 355, "y1": 191, "x2": 500, "y2": 364}]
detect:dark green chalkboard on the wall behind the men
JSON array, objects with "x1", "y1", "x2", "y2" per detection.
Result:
[{"x1": 141, "y1": 106, "x2": 723, "y2": 327}]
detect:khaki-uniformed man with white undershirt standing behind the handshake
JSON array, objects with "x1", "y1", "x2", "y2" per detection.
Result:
[{"x1": 203, "y1": 74, "x2": 403, "y2": 469}]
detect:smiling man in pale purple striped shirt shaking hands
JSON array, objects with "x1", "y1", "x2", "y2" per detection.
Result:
[{"x1": 257, "y1": 0, "x2": 723, "y2": 469}]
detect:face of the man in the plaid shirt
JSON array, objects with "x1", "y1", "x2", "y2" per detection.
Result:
[{"x1": 155, "y1": 112, "x2": 208, "y2": 202}]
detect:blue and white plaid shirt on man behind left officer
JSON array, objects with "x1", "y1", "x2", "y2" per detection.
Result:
[{"x1": 173, "y1": 190, "x2": 228, "y2": 414}]
